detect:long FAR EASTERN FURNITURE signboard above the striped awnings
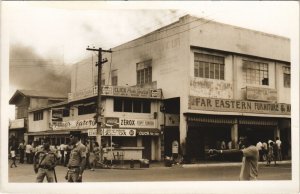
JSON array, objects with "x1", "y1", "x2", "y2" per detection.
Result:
[{"x1": 188, "y1": 96, "x2": 291, "y2": 115}]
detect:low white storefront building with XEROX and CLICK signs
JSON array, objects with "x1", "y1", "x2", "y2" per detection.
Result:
[{"x1": 28, "y1": 85, "x2": 161, "y2": 160}]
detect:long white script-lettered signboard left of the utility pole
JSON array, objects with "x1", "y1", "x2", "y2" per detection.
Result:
[{"x1": 52, "y1": 119, "x2": 97, "y2": 130}]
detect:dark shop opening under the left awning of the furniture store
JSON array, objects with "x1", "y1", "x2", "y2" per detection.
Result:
[{"x1": 187, "y1": 123, "x2": 231, "y2": 161}]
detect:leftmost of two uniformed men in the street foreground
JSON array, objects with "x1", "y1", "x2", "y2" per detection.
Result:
[{"x1": 33, "y1": 140, "x2": 57, "y2": 183}]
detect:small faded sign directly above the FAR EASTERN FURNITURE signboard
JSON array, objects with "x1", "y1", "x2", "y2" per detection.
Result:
[{"x1": 246, "y1": 86, "x2": 277, "y2": 102}]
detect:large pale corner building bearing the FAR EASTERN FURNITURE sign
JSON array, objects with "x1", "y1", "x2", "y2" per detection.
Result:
[{"x1": 96, "y1": 15, "x2": 291, "y2": 160}]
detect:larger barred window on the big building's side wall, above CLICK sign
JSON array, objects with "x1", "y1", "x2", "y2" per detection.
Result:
[{"x1": 136, "y1": 60, "x2": 152, "y2": 85}]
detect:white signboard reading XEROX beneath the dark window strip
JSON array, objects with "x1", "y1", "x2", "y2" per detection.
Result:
[{"x1": 119, "y1": 118, "x2": 156, "y2": 128}]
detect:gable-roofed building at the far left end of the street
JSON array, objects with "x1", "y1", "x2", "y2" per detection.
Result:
[{"x1": 9, "y1": 90, "x2": 67, "y2": 142}]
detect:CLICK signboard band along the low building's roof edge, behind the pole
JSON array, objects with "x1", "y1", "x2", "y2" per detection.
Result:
[{"x1": 68, "y1": 86, "x2": 162, "y2": 102}]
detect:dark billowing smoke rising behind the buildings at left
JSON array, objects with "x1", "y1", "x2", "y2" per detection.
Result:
[{"x1": 9, "y1": 45, "x2": 71, "y2": 94}]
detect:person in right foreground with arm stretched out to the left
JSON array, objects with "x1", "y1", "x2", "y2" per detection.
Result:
[{"x1": 209, "y1": 129, "x2": 259, "y2": 180}]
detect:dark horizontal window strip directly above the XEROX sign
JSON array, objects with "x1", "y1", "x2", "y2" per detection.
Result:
[{"x1": 114, "y1": 98, "x2": 151, "y2": 113}]
